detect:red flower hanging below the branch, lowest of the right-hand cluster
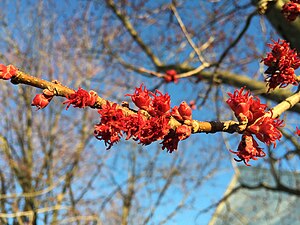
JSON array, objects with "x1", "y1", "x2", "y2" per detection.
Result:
[{"x1": 229, "y1": 134, "x2": 266, "y2": 166}]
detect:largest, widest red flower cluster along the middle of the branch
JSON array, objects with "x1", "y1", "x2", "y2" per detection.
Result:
[{"x1": 94, "y1": 85, "x2": 192, "y2": 152}]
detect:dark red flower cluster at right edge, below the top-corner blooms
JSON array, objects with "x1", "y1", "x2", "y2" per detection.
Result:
[{"x1": 262, "y1": 40, "x2": 300, "y2": 91}]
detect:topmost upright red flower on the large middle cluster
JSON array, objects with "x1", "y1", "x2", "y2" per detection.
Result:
[{"x1": 125, "y1": 84, "x2": 152, "y2": 111}]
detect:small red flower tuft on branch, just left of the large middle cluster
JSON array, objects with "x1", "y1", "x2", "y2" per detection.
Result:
[{"x1": 63, "y1": 87, "x2": 98, "y2": 110}]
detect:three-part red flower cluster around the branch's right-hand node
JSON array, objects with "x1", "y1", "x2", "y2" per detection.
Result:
[{"x1": 226, "y1": 88, "x2": 283, "y2": 165}]
